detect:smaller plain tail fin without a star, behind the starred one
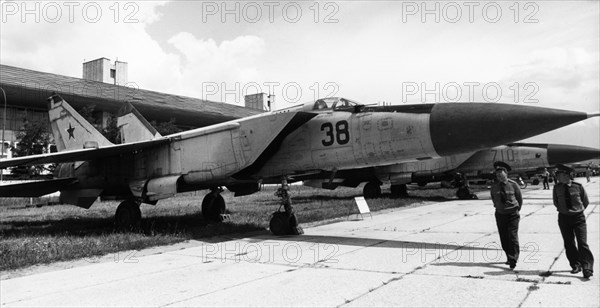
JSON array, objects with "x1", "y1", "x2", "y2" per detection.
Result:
[{"x1": 117, "y1": 103, "x2": 161, "y2": 143}]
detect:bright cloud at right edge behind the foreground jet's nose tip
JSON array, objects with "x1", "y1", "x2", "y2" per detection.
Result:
[{"x1": 496, "y1": 46, "x2": 600, "y2": 147}]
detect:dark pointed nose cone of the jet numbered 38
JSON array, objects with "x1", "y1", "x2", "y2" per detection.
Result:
[{"x1": 429, "y1": 103, "x2": 588, "y2": 156}]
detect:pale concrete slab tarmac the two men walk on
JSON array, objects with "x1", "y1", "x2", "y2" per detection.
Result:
[{"x1": 0, "y1": 177, "x2": 600, "y2": 307}]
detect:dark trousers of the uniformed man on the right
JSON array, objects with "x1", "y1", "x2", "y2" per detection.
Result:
[{"x1": 558, "y1": 213, "x2": 594, "y2": 271}]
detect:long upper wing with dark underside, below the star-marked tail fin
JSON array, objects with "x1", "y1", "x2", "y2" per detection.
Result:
[{"x1": 0, "y1": 138, "x2": 170, "y2": 169}]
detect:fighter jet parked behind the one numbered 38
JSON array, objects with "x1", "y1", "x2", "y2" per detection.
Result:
[{"x1": 304, "y1": 143, "x2": 600, "y2": 199}]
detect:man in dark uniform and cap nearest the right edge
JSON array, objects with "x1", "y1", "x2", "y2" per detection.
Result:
[{"x1": 552, "y1": 165, "x2": 594, "y2": 278}]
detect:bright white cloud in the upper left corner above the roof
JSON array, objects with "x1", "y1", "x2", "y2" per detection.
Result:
[{"x1": 0, "y1": 2, "x2": 180, "y2": 90}]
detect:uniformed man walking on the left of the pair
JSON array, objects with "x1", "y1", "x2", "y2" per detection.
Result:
[{"x1": 491, "y1": 162, "x2": 523, "y2": 269}]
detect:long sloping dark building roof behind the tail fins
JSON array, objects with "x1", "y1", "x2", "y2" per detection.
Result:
[{"x1": 0, "y1": 65, "x2": 261, "y2": 127}]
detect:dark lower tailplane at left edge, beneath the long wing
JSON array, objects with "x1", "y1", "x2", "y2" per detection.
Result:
[{"x1": 0, "y1": 178, "x2": 78, "y2": 197}]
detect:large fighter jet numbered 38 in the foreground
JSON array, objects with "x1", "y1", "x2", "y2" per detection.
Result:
[{"x1": 0, "y1": 95, "x2": 591, "y2": 234}]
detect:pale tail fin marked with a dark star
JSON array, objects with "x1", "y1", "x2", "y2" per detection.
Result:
[{"x1": 48, "y1": 94, "x2": 112, "y2": 151}]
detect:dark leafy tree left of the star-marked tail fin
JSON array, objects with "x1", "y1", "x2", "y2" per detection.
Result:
[{"x1": 11, "y1": 121, "x2": 50, "y2": 177}]
